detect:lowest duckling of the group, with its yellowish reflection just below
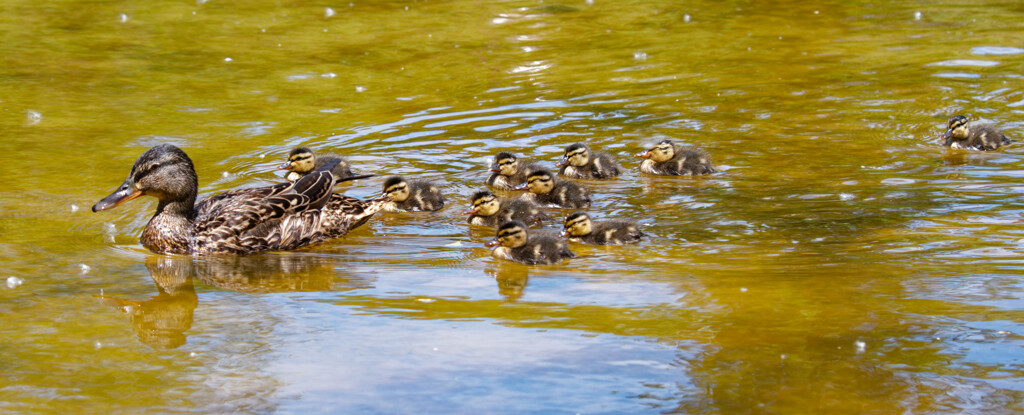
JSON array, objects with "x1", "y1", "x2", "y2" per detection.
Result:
[{"x1": 483, "y1": 220, "x2": 575, "y2": 264}]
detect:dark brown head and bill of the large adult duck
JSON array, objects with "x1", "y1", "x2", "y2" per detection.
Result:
[{"x1": 92, "y1": 144, "x2": 199, "y2": 212}]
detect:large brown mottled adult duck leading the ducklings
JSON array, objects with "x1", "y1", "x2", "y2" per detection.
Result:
[{"x1": 92, "y1": 144, "x2": 388, "y2": 255}]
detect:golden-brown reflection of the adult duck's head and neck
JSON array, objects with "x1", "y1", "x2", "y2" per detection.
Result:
[{"x1": 100, "y1": 256, "x2": 199, "y2": 348}]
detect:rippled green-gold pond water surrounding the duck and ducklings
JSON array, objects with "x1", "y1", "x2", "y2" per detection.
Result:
[{"x1": 0, "y1": 0, "x2": 1024, "y2": 414}]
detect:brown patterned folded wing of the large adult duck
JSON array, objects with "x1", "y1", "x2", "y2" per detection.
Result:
[{"x1": 195, "y1": 171, "x2": 334, "y2": 252}]
